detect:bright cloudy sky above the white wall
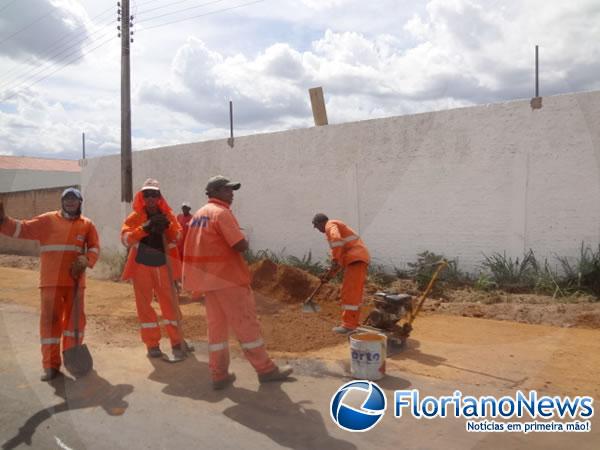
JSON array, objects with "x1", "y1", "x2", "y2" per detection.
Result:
[{"x1": 0, "y1": 0, "x2": 600, "y2": 159}]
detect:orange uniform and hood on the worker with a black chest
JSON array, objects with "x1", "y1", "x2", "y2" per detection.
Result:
[{"x1": 121, "y1": 191, "x2": 181, "y2": 348}]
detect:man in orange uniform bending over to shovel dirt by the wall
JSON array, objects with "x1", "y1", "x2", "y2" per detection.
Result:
[{"x1": 312, "y1": 213, "x2": 369, "y2": 334}]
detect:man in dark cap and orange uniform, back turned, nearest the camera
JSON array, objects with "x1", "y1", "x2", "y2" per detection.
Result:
[{"x1": 183, "y1": 175, "x2": 292, "y2": 390}]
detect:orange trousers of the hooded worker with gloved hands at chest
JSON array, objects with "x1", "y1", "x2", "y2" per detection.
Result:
[{"x1": 132, "y1": 264, "x2": 181, "y2": 348}]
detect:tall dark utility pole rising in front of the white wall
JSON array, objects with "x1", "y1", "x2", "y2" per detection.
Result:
[{"x1": 117, "y1": 0, "x2": 133, "y2": 203}]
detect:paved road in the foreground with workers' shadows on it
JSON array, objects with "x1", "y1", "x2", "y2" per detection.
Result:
[{"x1": 0, "y1": 303, "x2": 600, "y2": 450}]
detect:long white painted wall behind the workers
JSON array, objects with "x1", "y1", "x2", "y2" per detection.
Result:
[{"x1": 82, "y1": 92, "x2": 600, "y2": 270}]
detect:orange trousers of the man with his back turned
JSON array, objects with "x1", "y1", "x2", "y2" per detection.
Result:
[{"x1": 204, "y1": 286, "x2": 275, "y2": 381}]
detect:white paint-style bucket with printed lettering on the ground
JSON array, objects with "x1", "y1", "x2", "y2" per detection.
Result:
[{"x1": 350, "y1": 333, "x2": 387, "y2": 381}]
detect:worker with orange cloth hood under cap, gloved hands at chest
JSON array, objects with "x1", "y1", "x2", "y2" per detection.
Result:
[{"x1": 121, "y1": 178, "x2": 185, "y2": 360}]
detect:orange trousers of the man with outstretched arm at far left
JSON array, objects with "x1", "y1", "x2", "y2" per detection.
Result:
[{"x1": 40, "y1": 286, "x2": 85, "y2": 369}]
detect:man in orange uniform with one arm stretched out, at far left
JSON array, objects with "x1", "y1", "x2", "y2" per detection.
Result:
[{"x1": 0, "y1": 188, "x2": 100, "y2": 381}]
